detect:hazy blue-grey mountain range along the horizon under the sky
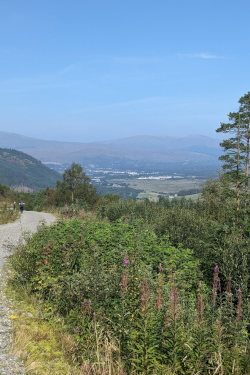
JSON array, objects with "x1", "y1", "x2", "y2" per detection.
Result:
[{"x1": 0, "y1": 132, "x2": 220, "y2": 173}]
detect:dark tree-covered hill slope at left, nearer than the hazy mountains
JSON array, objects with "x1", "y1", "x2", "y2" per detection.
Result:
[{"x1": 0, "y1": 148, "x2": 62, "y2": 190}]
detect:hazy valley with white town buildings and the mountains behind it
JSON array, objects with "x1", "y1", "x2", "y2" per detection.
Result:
[{"x1": 0, "y1": 132, "x2": 220, "y2": 199}]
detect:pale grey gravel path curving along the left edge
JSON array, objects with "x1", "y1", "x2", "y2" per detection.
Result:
[{"x1": 0, "y1": 211, "x2": 55, "y2": 375}]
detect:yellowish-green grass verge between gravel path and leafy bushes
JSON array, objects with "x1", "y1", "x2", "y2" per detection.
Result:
[{"x1": 7, "y1": 288, "x2": 81, "y2": 375}]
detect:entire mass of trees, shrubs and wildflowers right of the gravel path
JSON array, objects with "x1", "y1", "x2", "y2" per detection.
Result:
[{"x1": 1, "y1": 93, "x2": 250, "y2": 375}]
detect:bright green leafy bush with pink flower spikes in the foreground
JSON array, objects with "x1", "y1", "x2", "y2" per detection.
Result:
[{"x1": 9, "y1": 218, "x2": 247, "y2": 375}]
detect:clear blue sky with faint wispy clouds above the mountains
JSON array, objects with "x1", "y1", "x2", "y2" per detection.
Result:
[{"x1": 0, "y1": 0, "x2": 250, "y2": 141}]
